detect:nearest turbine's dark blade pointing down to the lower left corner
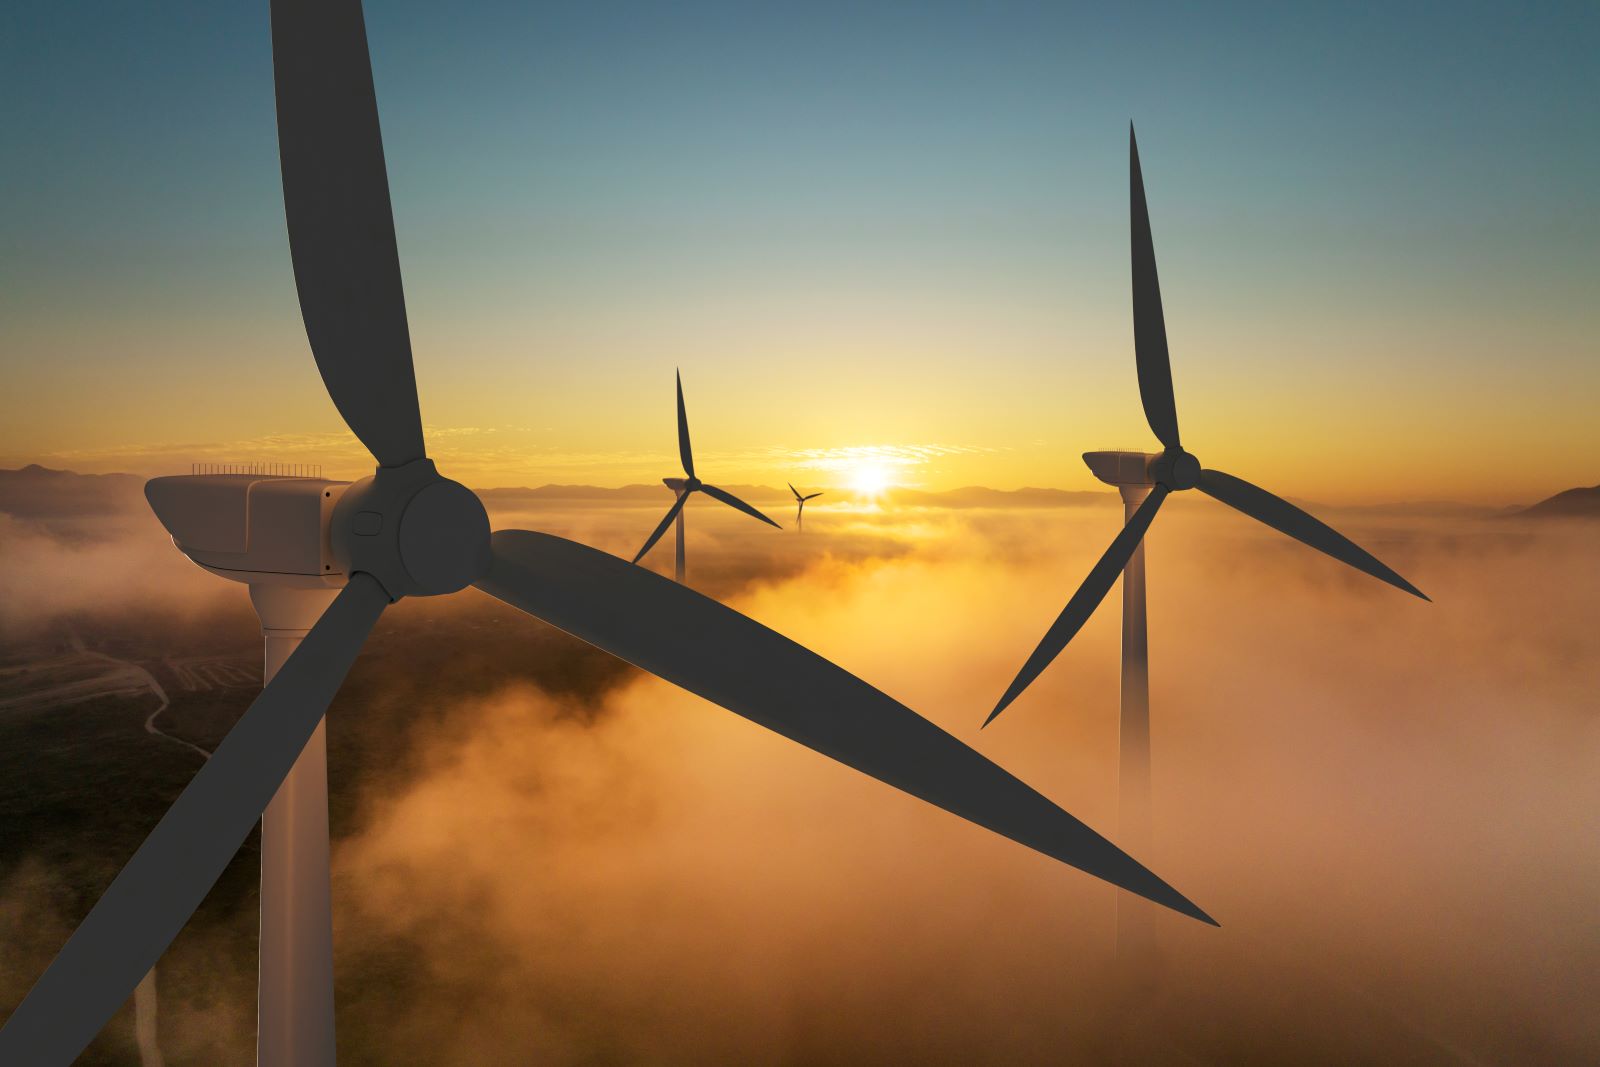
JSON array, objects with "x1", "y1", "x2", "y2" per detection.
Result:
[{"x1": 0, "y1": 574, "x2": 389, "y2": 1064}]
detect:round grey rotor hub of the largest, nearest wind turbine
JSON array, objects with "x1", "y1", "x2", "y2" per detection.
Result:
[{"x1": 331, "y1": 459, "x2": 490, "y2": 600}]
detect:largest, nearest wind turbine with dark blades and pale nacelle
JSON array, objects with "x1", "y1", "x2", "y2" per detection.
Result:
[{"x1": 0, "y1": 18, "x2": 1211, "y2": 1067}]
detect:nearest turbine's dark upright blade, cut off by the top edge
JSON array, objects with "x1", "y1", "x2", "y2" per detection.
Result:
[{"x1": 272, "y1": 0, "x2": 424, "y2": 467}]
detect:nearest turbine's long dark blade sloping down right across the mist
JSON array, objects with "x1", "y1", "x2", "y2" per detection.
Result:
[{"x1": 477, "y1": 530, "x2": 1213, "y2": 921}]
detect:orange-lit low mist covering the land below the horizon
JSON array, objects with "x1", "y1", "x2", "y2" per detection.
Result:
[{"x1": 0, "y1": 493, "x2": 1600, "y2": 1065}]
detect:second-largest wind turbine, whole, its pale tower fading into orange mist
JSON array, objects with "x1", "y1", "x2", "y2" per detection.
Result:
[{"x1": 984, "y1": 123, "x2": 1427, "y2": 959}]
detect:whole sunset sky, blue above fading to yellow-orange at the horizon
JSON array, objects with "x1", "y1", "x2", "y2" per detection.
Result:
[{"x1": 0, "y1": 0, "x2": 1600, "y2": 502}]
